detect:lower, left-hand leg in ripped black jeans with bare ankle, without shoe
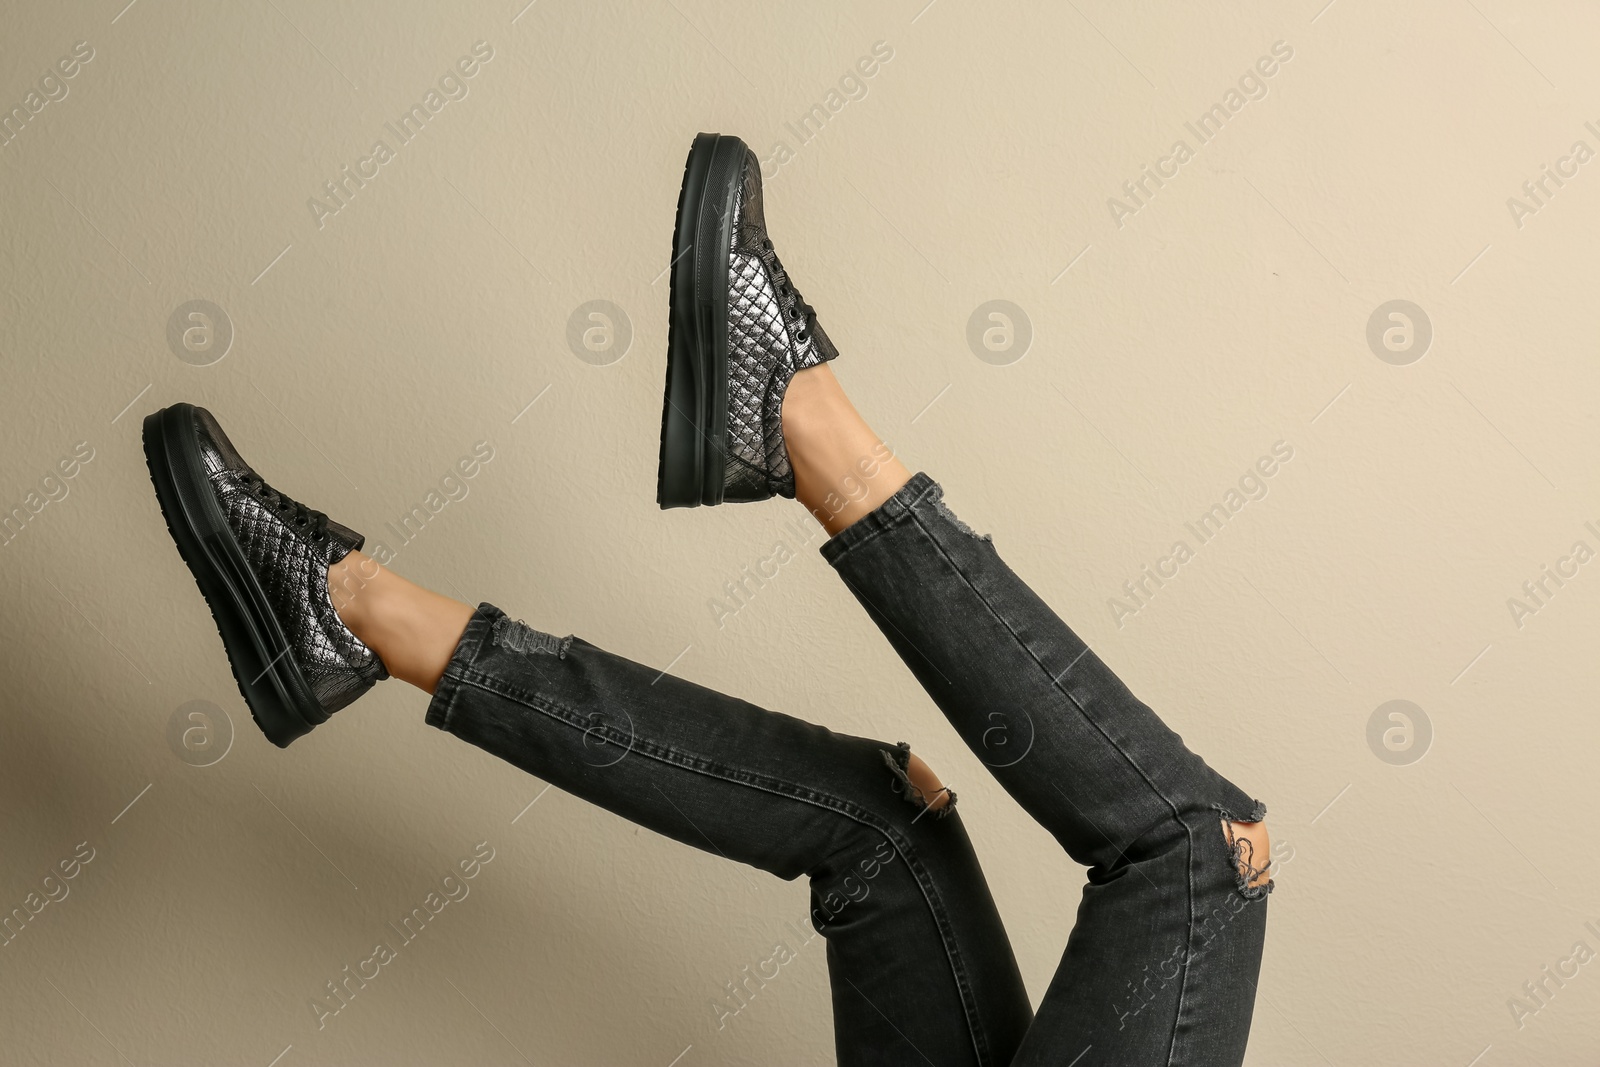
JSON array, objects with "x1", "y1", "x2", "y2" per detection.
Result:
[{"x1": 328, "y1": 552, "x2": 1032, "y2": 1065}]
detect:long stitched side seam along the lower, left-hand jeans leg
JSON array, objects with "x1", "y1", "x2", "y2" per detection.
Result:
[{"x1": 442, "y1": 665, "x2": 994, "y2": 1064}]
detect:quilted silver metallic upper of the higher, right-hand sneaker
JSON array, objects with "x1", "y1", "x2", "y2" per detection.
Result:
[{"x1": 723, "y1": 150, "x2": 838, "y2": 501}]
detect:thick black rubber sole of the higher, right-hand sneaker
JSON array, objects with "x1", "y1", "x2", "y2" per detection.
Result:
[{"x1": 656, "y1": 133, "x2": 746, "y2": 507}]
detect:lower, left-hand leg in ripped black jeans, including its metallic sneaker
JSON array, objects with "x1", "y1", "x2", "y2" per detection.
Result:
[{"x1": 144, "y1": 403, "x2": 1032, "y2": 1064}]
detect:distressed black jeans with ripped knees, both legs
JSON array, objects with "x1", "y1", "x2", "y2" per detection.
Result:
[{"x1": 427, "y1": 474, "x2": 1267, "y2": 1067}]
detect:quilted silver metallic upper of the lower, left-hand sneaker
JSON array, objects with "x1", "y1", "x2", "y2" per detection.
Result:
[{"x1": 195, "y1": 408, "x2": 389, "y2": 715}]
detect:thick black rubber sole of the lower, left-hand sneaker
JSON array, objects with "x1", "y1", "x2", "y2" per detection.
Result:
[{"x1": 144, "y1": 403, "x2": 328, "y2": 749}]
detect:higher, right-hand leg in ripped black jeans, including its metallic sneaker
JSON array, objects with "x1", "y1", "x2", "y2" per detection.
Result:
[{"x1": 656, "y1": 127, "x2": 1267, "y2": 1067}]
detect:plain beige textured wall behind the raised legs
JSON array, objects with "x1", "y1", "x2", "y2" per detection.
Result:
[{"x1": 0, "y1": 0, "x2": 1600, "y2": 1067}]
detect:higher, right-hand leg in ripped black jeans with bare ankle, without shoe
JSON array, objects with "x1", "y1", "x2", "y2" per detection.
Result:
[{"x1": 782, "y1": 365, "x2": 1270, "y2": 1065}]
